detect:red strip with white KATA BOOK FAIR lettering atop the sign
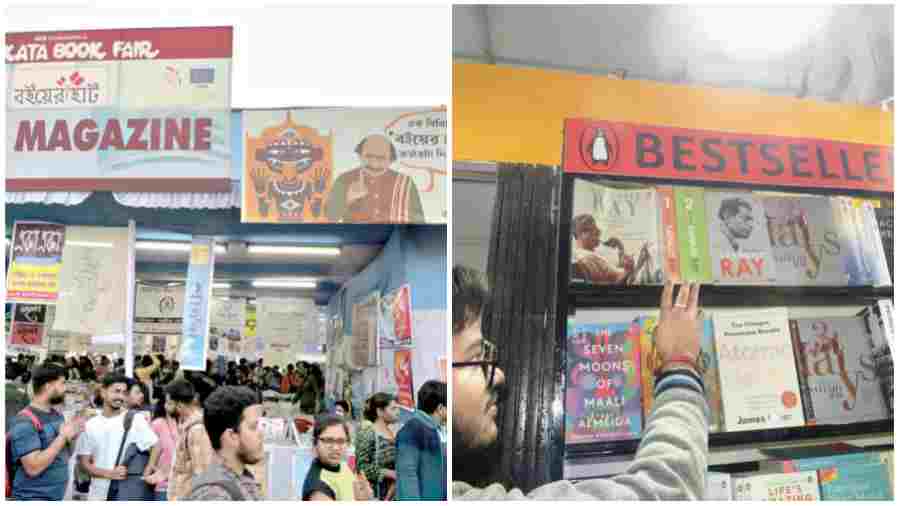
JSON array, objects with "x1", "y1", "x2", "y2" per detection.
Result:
[{"x1": 6, "y1": 26, "x2": 232, "y2": 63}]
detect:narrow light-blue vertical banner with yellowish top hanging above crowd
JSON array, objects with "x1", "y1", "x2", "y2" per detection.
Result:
[{"x1": 179, "y1": 237, "x2": 215, "y2": 371}]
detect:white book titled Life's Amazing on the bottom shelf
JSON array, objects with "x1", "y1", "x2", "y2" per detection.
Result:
[{"x1": 732, "y1": 471, "x2": 820, "y2": 501}]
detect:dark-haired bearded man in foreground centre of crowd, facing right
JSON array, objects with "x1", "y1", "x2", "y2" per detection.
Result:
[{"x1": 187, "y1": 386, "x2": 263, "y2": 501}]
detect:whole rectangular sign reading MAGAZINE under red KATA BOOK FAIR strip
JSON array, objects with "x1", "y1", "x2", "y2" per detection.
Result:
[{"x1": 6, "y1": 27, "x2": 232, "y2": 192}]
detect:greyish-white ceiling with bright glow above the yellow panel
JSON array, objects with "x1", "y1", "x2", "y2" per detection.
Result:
[{"x1": 453, "y1": 5, "x2": 894, "y2": 105}]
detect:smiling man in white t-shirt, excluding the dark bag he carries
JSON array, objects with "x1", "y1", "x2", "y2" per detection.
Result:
[{"x1": 76, "y1": 374, "x2": 159, "y2": 501}]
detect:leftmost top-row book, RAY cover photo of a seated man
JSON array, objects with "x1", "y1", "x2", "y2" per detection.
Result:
[{"x1": 572, "y1": 180, "x2": 663, "y2": 285}]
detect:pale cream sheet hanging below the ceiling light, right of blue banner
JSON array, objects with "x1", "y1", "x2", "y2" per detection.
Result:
[{"x1": 256, "y1": 298, "x2": 314, "y2": 365}]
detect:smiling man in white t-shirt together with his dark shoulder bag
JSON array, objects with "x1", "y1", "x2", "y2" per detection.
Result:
[{"x1": 77, "y1": 373, "x2": 159, "y2": 501}]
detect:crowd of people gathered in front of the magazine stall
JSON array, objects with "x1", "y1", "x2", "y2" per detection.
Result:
[{"x1": 6, "y1": 355, "x2": 447, "y2": 501}]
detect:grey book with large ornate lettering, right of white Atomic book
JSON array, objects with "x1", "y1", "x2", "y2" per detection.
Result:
[{"x1": 790, "y1": 317, "x2": 888, "y2": 425}]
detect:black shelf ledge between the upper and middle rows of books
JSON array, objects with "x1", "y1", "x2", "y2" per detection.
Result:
[{"x1": 568, "y1": 282, "x2": 894, "y2": 309}]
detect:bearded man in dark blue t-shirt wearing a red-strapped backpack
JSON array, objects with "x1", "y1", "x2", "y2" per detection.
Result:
[{"x1": 6, "y1": 364, "x2": 84, "y2": 501}]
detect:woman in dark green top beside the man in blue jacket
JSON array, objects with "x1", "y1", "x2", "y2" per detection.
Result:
[{"x1": 356, "y1": 392, "x2": 400, "y2": 501}]
